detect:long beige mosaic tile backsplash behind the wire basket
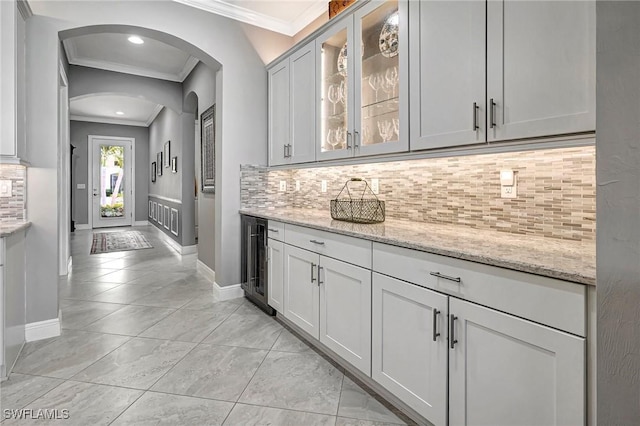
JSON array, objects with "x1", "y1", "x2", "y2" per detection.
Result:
[{"x1": 241, "y1": 146, "x2": 596, "y2": 241}]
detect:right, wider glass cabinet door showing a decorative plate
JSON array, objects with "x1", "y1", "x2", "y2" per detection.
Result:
[{"x1": 354, "y1": 0, "x2": 408, "y2": 155}]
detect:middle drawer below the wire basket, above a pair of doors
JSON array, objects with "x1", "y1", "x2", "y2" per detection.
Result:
[{"x1": 285, "y1": 224, "x2": 371, "y2": 269}]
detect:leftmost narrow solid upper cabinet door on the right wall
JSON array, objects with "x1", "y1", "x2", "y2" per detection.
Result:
[{"x1": 269, "y1": 59, "x2": 290, "y2": 166}]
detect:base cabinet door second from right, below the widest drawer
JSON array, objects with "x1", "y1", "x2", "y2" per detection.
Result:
[{"x1": 372, "y1": 273, "x2": 448, "y2": 425}]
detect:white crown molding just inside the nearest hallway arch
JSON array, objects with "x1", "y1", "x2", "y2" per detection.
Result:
[{"x1": 62, "y1": 38, "x2": 200, "y2": 83}]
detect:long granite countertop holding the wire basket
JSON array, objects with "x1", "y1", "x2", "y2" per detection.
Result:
[{"x1": 240, "y1": 209, "x2": 596, "y2": 285}]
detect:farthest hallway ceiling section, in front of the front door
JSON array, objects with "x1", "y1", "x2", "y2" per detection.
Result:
[{"x1": 69, "y1": 95, "x2": 163, "y2": 127}]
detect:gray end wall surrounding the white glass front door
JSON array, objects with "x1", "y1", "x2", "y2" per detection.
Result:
[{"x1": 71, "y1": 121, "x2": 151, "y2": 225}]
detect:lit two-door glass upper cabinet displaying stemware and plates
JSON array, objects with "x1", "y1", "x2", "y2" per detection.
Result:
[{"x1": 316, "y1": 0, "x2": 408, "y2": 160}]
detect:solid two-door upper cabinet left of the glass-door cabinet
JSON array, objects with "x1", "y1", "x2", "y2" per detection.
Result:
[{"x1": 268, "y1": 42, "x2": 316, "y2": 166}]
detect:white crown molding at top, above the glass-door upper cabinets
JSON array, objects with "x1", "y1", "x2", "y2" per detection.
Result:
[{"x1": 174, "y1": 0, "x2": 328, "y2": 37}]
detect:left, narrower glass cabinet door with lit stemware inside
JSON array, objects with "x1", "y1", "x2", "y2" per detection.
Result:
[{"x1": 318, "y1": 19, "x2": 354, "y2": 160}]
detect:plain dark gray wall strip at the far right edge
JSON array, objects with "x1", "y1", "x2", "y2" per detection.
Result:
[{"x1": 596, "y1": 1, "x2": 640, "y2": 425}]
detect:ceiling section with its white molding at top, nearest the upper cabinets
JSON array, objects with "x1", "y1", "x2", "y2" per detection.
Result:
[{"x1": 174, "y1": 0, "x2": 329, "y2": 37}]
